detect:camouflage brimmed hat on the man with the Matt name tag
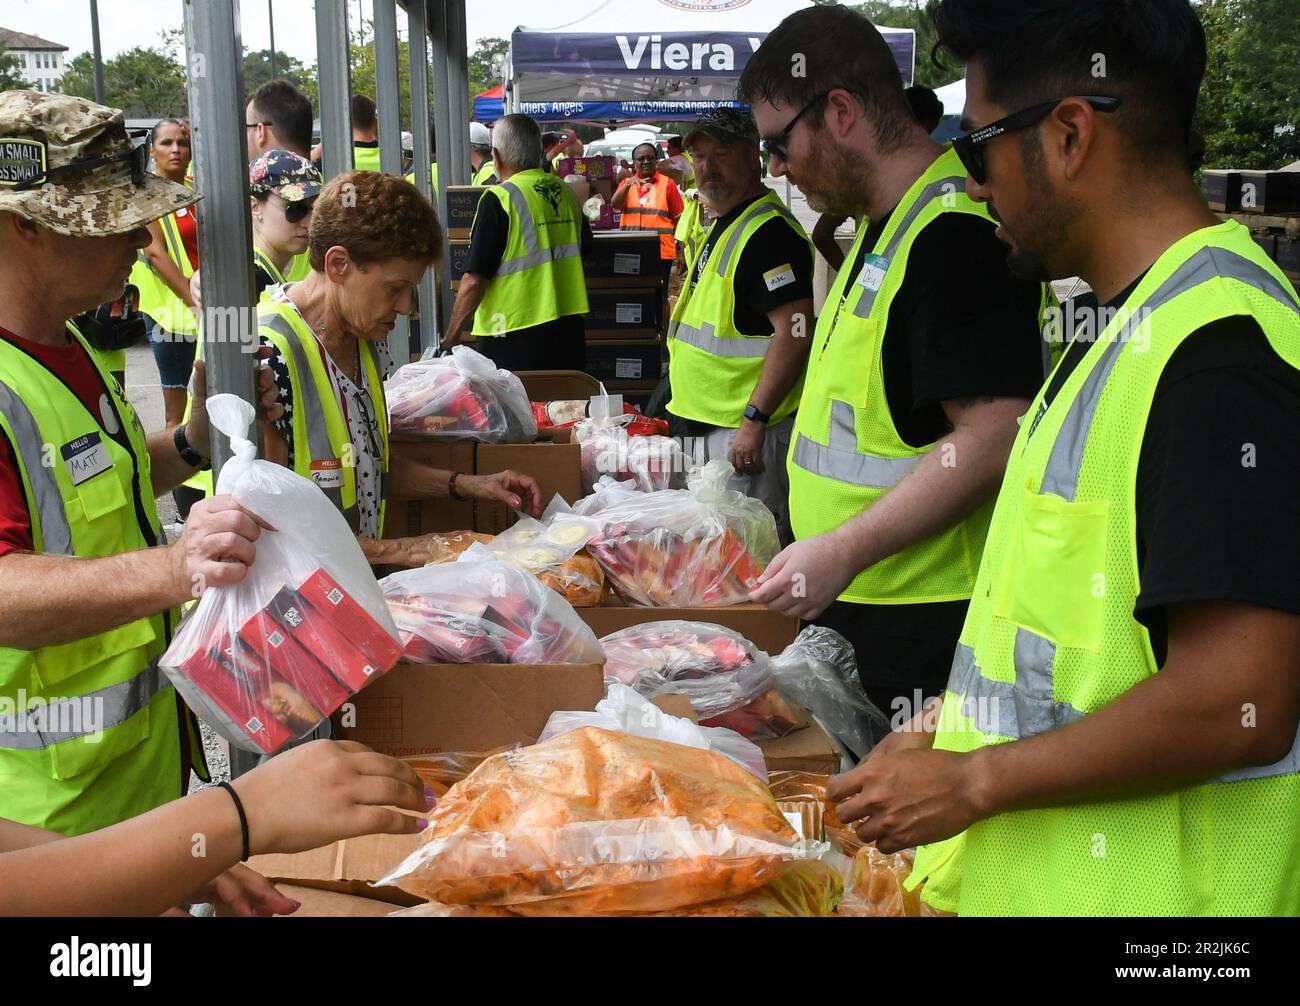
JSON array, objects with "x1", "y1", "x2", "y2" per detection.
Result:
[{"x1": 0, "y1": 91, "x2": 199, "y2": 238}]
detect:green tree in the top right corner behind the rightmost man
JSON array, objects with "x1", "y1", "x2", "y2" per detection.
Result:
[{"x1": 1197, "y1": 0, "x2": 1300, "y2": 169}]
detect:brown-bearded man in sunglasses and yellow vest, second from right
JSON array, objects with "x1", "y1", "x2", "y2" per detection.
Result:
[{"x1": 740, "y1": 6, "x2": 1044, "y2": 721}]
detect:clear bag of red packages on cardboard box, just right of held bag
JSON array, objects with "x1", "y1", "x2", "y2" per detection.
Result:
[{"x1": 380, "y1": 556, "x2": 605, "y2": 664}]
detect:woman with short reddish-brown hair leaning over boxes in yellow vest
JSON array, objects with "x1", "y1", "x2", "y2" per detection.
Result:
[{"x1": 257, "y1": 170, "x2": 541, "y2": 565}]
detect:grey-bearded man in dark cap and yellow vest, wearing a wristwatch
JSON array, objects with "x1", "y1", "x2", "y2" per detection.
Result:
[{"x1": 668, "y1": 108, "x2": 814, "y2": 542}]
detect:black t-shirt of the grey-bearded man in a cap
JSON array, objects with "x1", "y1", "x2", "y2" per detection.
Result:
[{"x1": 692, "y1": 195, "x2": 813, "y2": 335}]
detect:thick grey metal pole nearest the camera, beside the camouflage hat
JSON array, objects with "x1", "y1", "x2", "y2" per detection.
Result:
[{"x1": 185, "y1": 0, "x2": 257, "y2": 478}]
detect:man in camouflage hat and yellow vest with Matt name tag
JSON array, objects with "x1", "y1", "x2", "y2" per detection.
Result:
[{"x1": 0, "y1": 91, "x2": 274, "y2": 834}]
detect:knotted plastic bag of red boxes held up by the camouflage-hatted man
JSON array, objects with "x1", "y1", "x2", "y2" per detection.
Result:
[{"x1": 161, "y1": 395, "x2": 402, "y2": 754}]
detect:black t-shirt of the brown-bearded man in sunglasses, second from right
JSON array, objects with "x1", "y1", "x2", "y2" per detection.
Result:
[{"x1": 823, "y1": 212, "x2": 1044, "y2": 447}]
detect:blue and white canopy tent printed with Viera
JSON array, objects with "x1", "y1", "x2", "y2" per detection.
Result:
[{"x1": 504, "y1": 0, "x2": 917, "y2": 125}]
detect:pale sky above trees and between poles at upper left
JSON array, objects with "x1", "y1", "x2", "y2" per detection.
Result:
[{"x1": 0, "y1": 0, "x2": 572, "y2": 62}]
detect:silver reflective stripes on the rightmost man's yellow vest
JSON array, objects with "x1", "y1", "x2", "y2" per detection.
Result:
[{"x1": 948, "y1": 247, "x2": 1300, "y2": 781}]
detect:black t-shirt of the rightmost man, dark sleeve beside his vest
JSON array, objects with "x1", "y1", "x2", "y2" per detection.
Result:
[{"x1": 1047, "y1": 278, "x2": 1300, "y2": 665}]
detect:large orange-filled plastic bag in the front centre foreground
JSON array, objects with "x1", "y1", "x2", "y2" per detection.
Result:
[{"x1": 378, "y1": 727, "x2": 822, "y2": 915}]
